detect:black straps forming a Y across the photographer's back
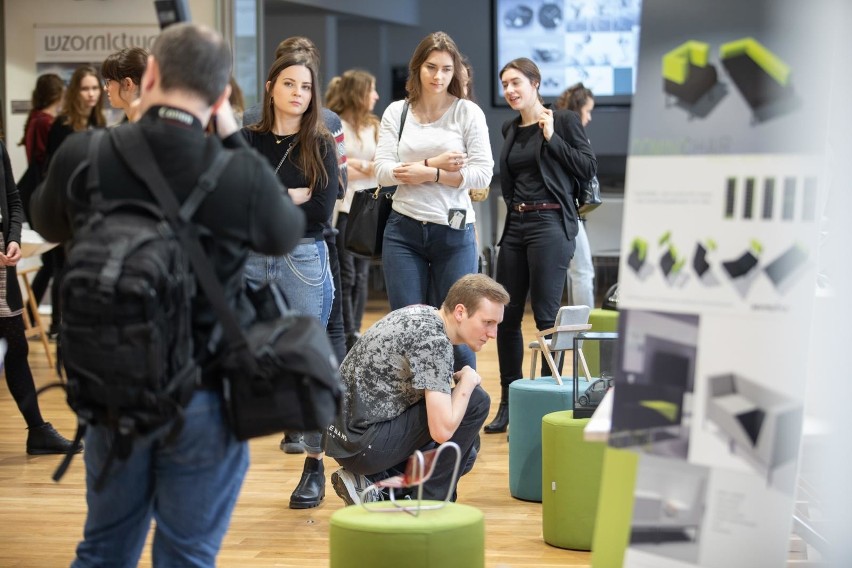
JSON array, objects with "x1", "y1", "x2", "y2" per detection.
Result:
[{"x1": 107, "y1": 125, "x2": 256, "y2": 370}]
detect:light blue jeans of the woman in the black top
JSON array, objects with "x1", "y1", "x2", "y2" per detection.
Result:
[{"x1": 245, "y1": 239, "x2": 334, "y2": 326}]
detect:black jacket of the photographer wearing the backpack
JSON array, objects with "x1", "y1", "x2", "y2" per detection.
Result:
[{"x1": 31, "y1": 107, "x2": 305, "y2": 370}]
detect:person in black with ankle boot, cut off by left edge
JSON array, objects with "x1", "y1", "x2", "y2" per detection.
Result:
[{"x1": 0, "y1": 142, "x2": 83, "y2": 454}]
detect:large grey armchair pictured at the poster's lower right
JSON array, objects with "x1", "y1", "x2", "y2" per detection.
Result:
[{"x1": 706, "y1": 373, "x2": 803, "y2": 483}]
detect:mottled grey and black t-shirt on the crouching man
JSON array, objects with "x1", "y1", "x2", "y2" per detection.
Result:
[{"x1": 327, "y1": 306, "x2": 453, "y2": 458}]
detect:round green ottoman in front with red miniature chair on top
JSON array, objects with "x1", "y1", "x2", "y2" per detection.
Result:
[{"x1": 329, "y1": 501, "x2": 485, "y2": 568}]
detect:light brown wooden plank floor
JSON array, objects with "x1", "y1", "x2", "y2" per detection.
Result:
[{"x1": 0, "y1": 300, "x2": 591, "y2": 568}]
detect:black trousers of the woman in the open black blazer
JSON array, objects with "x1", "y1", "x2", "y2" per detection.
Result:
[{"x1": 497, "y1": 210, "x2": 574, "y2": 387}]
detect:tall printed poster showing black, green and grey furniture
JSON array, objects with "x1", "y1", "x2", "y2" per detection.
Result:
[{"x1": 604, "y1": 0, "x2": 825, "y2": 568}]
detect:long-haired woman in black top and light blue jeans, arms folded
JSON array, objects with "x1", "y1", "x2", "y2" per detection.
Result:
[{"x1": 242, "y1": 52, "x2": 339, "y2": 509}]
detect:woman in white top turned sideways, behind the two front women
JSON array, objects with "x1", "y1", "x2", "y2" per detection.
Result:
[{"x1": 326, "y1": 69, "x2": 379, "y2": 351}]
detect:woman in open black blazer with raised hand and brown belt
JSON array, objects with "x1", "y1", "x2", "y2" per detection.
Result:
[{"x1": 485, "y1": 57, "x2": 597, "y2": 433}]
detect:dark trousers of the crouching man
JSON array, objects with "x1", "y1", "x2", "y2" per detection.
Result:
[{"x1": 336, "y1": 387, "x2": 491, "y2": 500}]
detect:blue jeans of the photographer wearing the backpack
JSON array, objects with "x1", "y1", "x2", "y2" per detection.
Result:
[{"x1": 72, "y1": 390, "x2": 249, "y2": 568}]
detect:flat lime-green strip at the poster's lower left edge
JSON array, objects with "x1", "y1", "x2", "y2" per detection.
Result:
[{"x1": 592, "y1": 448, "x2": 639, "y2": 568}]
